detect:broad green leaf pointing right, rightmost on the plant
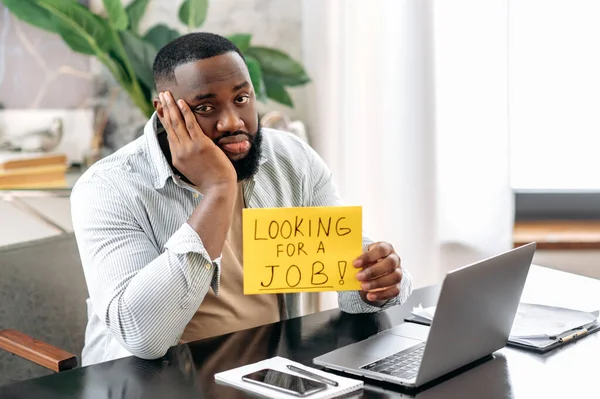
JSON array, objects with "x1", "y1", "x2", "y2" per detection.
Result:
[{"x1": 246, "y1": 47, "x2": 310, "y2": 86}]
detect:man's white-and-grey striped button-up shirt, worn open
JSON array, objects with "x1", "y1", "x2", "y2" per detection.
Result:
[{"x1": 71, "y1": 114, "x2": 412, "y2": 365}]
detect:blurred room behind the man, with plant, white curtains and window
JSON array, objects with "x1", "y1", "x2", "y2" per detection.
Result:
[{"x1": 0, "y1": 0, "x2": 600, "y2": 308}]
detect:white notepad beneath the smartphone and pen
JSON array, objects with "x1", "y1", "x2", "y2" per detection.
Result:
[{"x1": 215, "y1": 356, "x2": 364, "y2": 399}]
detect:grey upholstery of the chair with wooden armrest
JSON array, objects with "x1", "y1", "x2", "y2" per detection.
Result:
[{"x1": 0, "y1": 234, "x2": 88, "y2": 385}]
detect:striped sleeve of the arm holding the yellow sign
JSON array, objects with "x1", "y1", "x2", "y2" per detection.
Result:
[{"x1": 306, "y1": 142, "x2": 412, "y2": 313}]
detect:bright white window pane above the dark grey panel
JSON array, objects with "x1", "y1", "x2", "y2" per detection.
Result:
[{"x1": 508, "y1": 0, "x2": 600, "y2": 191}]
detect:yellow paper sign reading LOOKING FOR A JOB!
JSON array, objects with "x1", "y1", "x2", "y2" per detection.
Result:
[{"x1": 243, "y1": 206, "x2": 362, "y2": 294}]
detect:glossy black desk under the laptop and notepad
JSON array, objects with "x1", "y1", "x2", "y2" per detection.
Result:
[{"x1": 0, "y1": 267, "x2": 600, "y2": 399}]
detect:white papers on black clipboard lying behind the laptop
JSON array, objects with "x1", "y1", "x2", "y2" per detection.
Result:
[{"x1": 412, "y1": 303, "x2": 599, "y2": 346}]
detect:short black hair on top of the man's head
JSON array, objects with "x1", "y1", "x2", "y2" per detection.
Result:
[{"x1": 152, "y1": 32, "x2": 245, "y2": 84}]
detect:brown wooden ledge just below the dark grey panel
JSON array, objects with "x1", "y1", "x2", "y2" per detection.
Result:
[{"x1": 513, "y1": 220, "x2": 600, "y2": 250}]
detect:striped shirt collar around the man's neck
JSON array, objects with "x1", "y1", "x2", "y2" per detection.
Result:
[{"x1": 144, "y1": 112, "x2": 268, "y2": 189}]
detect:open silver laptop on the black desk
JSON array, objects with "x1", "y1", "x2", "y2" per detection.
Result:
[{"x1": 313, "y1": 242, "x2": 536, "y2": 388}]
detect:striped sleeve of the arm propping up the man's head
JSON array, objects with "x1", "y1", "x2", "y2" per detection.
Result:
[{"x1": 71, "y1": 176, "x2": 220, "y2": 359}]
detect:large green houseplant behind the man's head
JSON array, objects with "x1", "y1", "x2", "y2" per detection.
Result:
[{"x1": 0, "y1": 0, "x2": 309, "y2": 117}]
